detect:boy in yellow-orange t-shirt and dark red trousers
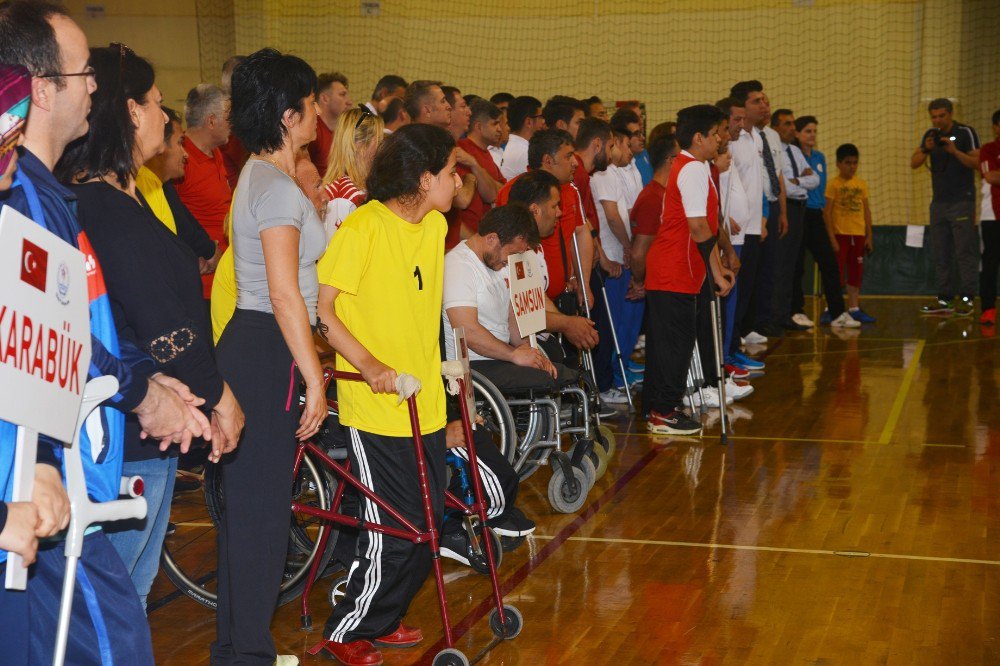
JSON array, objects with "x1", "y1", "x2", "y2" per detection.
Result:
[{"x1": 823, "y1": 143, "x2": 875, "y2": 324}]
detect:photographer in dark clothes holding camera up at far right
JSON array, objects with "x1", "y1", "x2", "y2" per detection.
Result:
[{"x1": 910, "y1": 97, "x2": 979, "y2": 317}]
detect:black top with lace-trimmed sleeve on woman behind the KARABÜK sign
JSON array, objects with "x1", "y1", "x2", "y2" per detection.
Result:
[{"x1": 72, "y1": 182, "x2": 223, "y2": 461}]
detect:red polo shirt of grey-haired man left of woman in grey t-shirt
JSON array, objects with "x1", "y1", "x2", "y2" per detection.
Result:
[{"x1": 175, "y1": 137, "x2": 233, "y2": 298}]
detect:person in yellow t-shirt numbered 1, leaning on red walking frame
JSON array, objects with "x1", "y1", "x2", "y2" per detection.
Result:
[{"x1": 315, "y1": 124, "x2": 462, "y2": 665}]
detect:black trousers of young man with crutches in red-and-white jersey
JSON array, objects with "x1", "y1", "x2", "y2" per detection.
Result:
[{"x1": 642, "y1": 290, "x2": 698, "y2": 414}]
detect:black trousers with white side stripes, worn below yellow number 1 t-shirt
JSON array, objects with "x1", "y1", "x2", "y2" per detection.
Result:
[{"x1": 324, "y1": 428, "x2": 445, "y2": 643}]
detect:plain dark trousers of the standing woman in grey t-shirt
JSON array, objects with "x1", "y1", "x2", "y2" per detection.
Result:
[{"x1": 211, "y1": 310, "x2": 301, "y2": 665}]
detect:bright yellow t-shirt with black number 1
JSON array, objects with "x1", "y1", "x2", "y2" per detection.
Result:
[{"x1": 317, "y1": 201, "x2": 448, "y2": 437}]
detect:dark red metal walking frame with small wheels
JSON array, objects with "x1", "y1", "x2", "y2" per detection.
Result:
[{"x1": 292, "y1": 369, "x2": 523, "y2": 666}]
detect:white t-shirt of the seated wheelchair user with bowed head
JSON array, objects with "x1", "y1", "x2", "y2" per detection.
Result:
[{"x1": 441, "y1": 241, "x2": 510, "y2": 361}]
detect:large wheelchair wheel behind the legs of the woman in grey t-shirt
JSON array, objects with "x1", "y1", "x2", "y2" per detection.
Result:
[{"x1": 160, "y1": 446, "x2": 337, "y2": 610}]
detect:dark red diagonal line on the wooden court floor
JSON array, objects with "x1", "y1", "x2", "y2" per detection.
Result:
[{"x1": 417, "y1": 440, "x2": 659, "y2": 664}]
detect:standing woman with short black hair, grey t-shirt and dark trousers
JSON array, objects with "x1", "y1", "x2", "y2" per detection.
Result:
[{"x1": 212, "y1": 49, "x2": 326, "y2": 666}]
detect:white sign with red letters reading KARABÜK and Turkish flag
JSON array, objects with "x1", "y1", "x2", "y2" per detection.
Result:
[{"x1": 0, "y1": 206, "x2": 91, "y2": 442}]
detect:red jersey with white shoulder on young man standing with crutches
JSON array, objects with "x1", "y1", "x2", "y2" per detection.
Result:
[{"x1": 646, "y1": 151, "x2": 719, "y2": 294}]
